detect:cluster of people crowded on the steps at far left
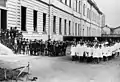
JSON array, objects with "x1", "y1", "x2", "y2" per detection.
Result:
[{"x1": 0, "y1": 27, "x2": 23, "y2": 51}]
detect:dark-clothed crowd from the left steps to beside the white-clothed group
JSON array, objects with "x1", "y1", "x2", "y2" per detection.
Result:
[{"x1": 1, "y1": 27, "x2": 71, "y2": 56}]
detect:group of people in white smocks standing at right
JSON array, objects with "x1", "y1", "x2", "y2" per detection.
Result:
[{"x1": 70, "y1": 40, "x2": 120, "y2": 63}]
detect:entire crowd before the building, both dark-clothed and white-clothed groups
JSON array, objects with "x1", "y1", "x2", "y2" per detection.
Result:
[{"x1": 1, "y1": 27, "x2": 120, "y2": 63}]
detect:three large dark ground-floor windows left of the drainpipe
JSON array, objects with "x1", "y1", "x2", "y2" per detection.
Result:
[{"x1": 21, "y1": 6, "x2": 46, "y2": 33}]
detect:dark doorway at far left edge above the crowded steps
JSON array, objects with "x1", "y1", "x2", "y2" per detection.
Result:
[{"x1": 1, "y1": 10, "x2": 7, "y2": 30}]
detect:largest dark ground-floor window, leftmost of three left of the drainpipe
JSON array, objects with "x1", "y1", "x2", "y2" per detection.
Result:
[{"x1": 21, "y1": 6, "x2": 26, "y2": 31}]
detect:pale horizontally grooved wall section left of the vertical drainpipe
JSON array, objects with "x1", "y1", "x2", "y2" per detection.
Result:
[{"x1": 7, "y1": 0, "x2": 48, "y2": 40}]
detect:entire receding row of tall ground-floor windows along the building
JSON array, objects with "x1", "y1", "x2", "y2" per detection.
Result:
[{"x1": 21, "y1": 6, "x2": 101, "y2": 36}]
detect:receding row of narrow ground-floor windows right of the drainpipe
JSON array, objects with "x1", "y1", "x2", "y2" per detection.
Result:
[{"x1": 53, "y1": 16, "x2": 82, "y2": 36}]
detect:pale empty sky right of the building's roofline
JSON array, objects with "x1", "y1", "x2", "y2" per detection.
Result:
[{"x1": 94, "y1": 0, "x2": 120, "y2": 28}]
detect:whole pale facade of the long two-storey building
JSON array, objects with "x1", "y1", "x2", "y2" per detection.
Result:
[{"x1": 1, "y1": 0, "x2": 105, "y2": 40}]
